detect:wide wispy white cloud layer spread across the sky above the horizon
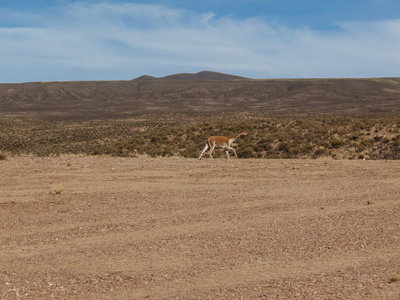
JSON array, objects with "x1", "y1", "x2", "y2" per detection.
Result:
[{"x1": 0, "y1": 3, "x2": 400, "y2": 82}]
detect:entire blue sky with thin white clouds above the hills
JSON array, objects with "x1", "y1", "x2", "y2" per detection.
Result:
[{"x1": 0, "y1": 0, "x2": 400, "y2": 83}]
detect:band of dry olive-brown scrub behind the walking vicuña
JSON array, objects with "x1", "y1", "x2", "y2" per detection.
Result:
[{"x1": 0, "y1": 112, "x2": 400, "y2": 159}]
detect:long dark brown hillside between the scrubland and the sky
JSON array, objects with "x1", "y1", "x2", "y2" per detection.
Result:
[{"x1": 0, "y1": 77, "x2": 400, "y2": 119}]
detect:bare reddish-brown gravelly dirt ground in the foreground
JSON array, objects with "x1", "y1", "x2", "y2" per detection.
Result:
[{"x1": 0, "y1": 156, "x2": 400, "y2": 299}]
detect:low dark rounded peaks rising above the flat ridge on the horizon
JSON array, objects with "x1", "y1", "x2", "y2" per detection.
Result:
[{"x1": 133, "y1": 71, "x2": 248, "y2": 81}]
